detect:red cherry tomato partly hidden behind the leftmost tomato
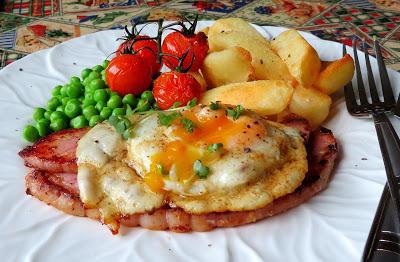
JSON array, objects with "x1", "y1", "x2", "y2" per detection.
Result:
[{"x1": 115, "y1": 35, "x2": 161, "y2": 75}]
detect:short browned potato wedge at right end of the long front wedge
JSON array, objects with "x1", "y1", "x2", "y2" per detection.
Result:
[{"x1": 289, "y1": 86, "x2": 332, "y2": 126}]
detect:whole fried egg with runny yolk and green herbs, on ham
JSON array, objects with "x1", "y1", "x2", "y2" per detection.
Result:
[{"x1": 77, "y1": 105, "x2": 307, "y2": 227}]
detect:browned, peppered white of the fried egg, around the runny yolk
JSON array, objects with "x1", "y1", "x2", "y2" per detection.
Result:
[{"x1": 77, "y1": 106, "x2": 307, "y2": 224}]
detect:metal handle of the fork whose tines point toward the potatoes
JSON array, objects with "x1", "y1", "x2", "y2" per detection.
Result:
[{"x1": 373, "y1": 112, "x2": 400, "y2": 221}]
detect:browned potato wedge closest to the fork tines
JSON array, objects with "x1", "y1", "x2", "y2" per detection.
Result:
[{"x1": 314, "y1": 54, "x2": 354, "y2": 95}]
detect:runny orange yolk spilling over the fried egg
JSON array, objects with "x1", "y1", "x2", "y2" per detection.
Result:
[{"x1": 144, "y1": 108, "x2": 246, "y2": 192}]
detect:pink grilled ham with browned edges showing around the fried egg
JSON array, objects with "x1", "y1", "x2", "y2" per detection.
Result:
[{"x1": 20, "y1": 119, "x2": 338, "y2": 233}]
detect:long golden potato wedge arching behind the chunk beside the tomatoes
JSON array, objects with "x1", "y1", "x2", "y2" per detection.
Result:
[{"x1": 208, "y1": 31, "x2": 294, "y2": 80}]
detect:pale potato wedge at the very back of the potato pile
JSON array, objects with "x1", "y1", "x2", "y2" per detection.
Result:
[{"x1": 208, "y1": 17, "x2": 267, "y2": 42}]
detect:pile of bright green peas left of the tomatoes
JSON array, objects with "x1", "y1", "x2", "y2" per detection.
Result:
[{"x1": 23, "y1": 60, "x2": 157, "y2": 142}]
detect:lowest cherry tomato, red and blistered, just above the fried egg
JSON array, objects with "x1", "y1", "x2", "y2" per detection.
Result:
[{"x1": 153, "y1": 71, "x2": 201, "y2": 110}]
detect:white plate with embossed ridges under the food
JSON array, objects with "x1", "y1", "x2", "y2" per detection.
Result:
[{"x1": 0, "y1": 23, "x2": 400, "y2": 262}]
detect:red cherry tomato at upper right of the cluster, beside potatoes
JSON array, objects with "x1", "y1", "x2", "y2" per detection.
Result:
[{"x1": 161, "y1": 32, "x2": 208, "y2": 71}]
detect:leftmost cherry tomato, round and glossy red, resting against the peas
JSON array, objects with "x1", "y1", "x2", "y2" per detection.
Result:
[{"x1": 106, "y1": 54, "x2": 152, "y2": 96}]
